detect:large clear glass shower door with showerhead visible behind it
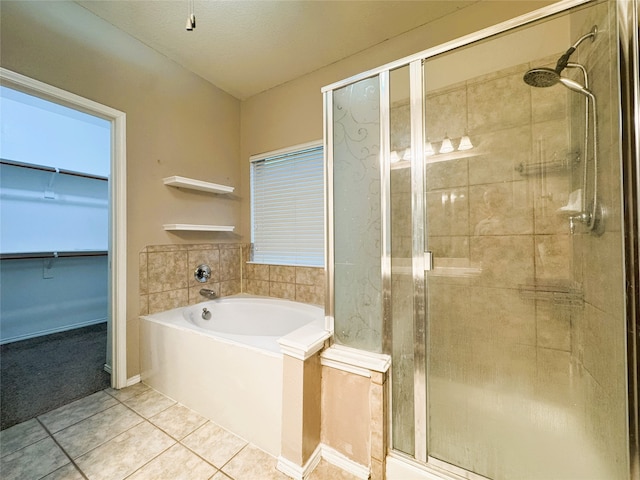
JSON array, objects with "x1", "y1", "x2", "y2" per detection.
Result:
[{"x1": 423, "y1": 4, "x2": 628, "y2": 480}]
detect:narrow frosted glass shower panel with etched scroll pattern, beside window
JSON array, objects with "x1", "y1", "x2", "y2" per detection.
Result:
[{"x1": 333, "y1": 77, "x2": 382, "y2": 352}]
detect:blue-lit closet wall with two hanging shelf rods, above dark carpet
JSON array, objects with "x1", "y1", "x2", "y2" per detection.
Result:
[{"x1": 0, "y1": 87, "x2": 111, "y2": 343}]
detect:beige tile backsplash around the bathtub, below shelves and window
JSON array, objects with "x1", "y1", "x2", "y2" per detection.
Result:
[{"x1": 139, "y1": 243, "x2": 325, "y2": 315}]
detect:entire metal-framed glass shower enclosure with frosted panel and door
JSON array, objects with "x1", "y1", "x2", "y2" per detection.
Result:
[{"x1": 324, "y1": 1, "x2": 637, "y2": 480}]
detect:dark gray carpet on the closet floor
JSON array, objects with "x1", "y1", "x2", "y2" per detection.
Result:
[{"x1": 0, "y1": 323, "x2": 110, "y2": 430}]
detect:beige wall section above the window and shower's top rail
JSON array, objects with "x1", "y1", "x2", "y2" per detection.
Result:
[{"x1": 240, "y1": 0, "x2": 556, "y2": 238}]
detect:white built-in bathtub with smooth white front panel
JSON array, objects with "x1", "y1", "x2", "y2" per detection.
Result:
[{"x1": 140, "y1": 294, "x2": 324, "y2": 456}]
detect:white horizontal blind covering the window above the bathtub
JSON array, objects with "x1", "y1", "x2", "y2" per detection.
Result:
[{"x1": 251, "y1": 145, "x2": 324, "y2": 266}]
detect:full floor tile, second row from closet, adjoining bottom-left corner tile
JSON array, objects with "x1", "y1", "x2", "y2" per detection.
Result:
[{"x1": 54, "y1": 404, "x2": 144, "y2": 458}]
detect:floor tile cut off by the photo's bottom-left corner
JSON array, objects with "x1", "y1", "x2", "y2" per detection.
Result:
[{"x1": 0, "y1": 437, "x2": 69, "y2": 480}]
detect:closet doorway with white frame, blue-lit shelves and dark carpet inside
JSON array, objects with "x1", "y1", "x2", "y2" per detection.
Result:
[{"x1": 0, "y1": 69, "x2": 126, "y2": 428}]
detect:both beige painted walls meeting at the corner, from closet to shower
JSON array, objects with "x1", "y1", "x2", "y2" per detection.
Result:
[{"x1": 0, "y1": 0, "x2": 554, "y2": 382}]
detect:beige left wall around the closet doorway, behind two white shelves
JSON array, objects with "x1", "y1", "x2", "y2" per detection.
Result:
[{"x1": 0, "y1": 1, "x2": 240, "y2": 377}]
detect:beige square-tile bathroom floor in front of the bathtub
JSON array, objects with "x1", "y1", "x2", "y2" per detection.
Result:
[{"x1": 0, "y1": 383, "x2": 356, "y2": 480}]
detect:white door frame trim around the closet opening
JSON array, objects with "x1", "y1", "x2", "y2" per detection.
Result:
[{"x1": 0, "y1": 67, "x2": 127, "y2": 388}]
